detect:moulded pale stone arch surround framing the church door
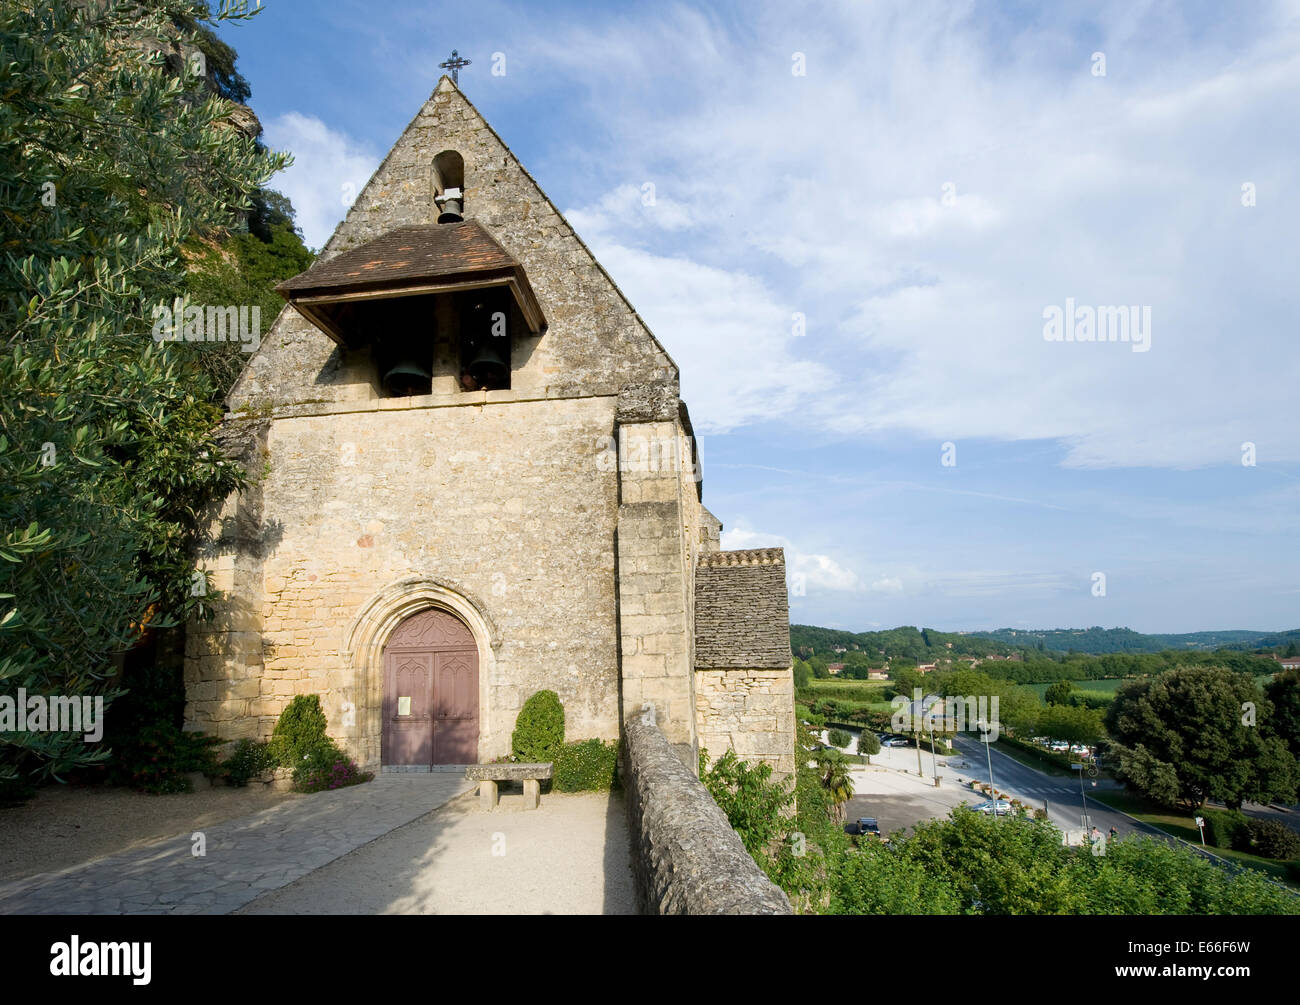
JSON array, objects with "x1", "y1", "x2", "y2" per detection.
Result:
[{"x1": 342, "y1": 576, "x2": 502, "y2": 770}]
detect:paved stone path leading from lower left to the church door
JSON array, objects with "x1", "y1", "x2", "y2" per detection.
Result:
[{"x1": 0, "y1": 772, "x2": 472, "y2": 914}]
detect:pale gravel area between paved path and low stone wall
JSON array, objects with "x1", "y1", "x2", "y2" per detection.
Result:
[{"x1": 237, "y1": 792, "x2": 636, "y2": 914}]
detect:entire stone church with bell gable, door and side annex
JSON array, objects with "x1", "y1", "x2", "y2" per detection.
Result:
[{"x1": 185, "y1": 77, "x2": 794, "y2": 776}]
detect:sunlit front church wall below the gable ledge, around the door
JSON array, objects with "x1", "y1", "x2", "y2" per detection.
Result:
[{"x1": 187, "y1": 398, "x2": 619, "y2": 767}]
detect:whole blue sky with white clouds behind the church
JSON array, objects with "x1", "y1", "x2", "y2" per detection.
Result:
[{"x1": 224, "y1": 0, "x2": 1300, "y2": 632}]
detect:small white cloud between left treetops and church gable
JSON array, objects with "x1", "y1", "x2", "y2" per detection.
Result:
[{"x1": 265, "y1": 112, "x2": 380, "y2": 248}]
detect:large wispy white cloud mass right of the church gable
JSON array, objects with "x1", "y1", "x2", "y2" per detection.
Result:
[{"x1": 549, "y1": 4, "x2": 1300, "y2": 468}]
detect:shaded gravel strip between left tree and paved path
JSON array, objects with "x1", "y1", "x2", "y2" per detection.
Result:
[{"x1": 0, "y1": 784, "x2": 303, "y2": 881}]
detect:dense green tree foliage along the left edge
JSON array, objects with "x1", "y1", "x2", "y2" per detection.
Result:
[{"x1": 0, "y1": 0, "x2": 287, "y2": 777}]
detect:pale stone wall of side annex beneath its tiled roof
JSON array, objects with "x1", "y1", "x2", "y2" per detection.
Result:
[{"x1": 696, "y1": 670, "x2": 794, "y2": 780}]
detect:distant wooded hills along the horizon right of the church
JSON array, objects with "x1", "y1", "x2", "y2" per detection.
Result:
[{"x1": 790, "y1": 624, "x2": 1300, "y2": 662}]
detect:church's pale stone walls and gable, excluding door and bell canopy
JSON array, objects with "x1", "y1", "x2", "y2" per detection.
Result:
[{"x1": 186, "y1": 78, "x2": 793, "y2": 785}]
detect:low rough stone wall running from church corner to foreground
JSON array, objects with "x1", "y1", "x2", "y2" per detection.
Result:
[{"x1": 623, "y1": 710, "x2": 792, "y2": 914}]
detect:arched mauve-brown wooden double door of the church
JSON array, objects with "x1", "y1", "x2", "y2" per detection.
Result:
[{"x1": 381, "y1": 607, "x2": 478, "y2": 767}]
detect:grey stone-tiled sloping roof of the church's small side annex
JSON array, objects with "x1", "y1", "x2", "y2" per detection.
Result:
[{"x1": 696, "y1": 547, "x2": 793, "y2": 670}]
